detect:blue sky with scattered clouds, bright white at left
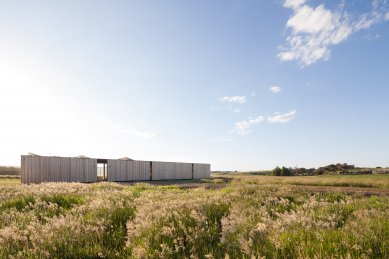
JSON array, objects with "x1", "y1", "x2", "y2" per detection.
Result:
[{"x1": 0, "y1": 0, "x2": 389, "y2": 171}]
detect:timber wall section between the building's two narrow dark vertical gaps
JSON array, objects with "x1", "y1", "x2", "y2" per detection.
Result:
[{"x1": 152, "y1": 162, "x2": 192, "y2": 180}]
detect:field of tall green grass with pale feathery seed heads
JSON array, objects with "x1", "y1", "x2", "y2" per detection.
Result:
[{"x1": 0, "y1": 174, "x2": 389, "y2": 258}]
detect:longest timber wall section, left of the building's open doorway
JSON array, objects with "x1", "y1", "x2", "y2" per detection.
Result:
[{"x1": 21, "y1": 156, "x2": 97, "y2": 184}]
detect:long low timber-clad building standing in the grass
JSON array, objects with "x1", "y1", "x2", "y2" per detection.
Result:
[{"x1": 21, "y1": 154, "x2": 210, "y2": 184}]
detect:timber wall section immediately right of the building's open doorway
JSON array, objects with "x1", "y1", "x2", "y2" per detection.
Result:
[{"x1": 107, "y1": 159, "x2": 150, "y2": 182}]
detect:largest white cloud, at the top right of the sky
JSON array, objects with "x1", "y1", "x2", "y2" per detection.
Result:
[{"x1": 278, "y1": 0, "x2": 389, "y2": 66}]
